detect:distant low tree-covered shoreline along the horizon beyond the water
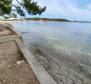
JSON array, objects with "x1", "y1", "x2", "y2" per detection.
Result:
[{"x1": 0, "y1": 17, "x2": 91, "y2": 23}]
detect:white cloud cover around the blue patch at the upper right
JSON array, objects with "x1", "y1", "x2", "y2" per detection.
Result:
[{"x1": 37, "y1": 0, "x2": 91, "y2": 20}]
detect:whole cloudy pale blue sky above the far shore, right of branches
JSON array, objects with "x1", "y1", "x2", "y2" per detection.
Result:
[{"x1": 13, "y1": 0, "x2": 91, "y2": 21}]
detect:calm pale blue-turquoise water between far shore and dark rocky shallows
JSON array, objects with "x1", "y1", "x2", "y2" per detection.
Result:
[{"x1": 12, "y1": 21, "x2": 91, "y2": 55}]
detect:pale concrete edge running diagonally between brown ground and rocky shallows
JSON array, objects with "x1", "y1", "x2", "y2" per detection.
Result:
[{"x1": 16, "y1": 39, "x2": 57, "y2": 84}]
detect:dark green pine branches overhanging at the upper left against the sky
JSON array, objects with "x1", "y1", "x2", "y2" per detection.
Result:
[{"x1": 0, "y1": 0, "x2": 46, "y2": 16}]
